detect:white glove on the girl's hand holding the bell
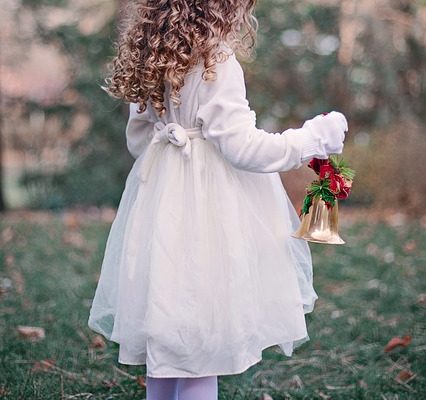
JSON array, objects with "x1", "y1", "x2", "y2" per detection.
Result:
[{"x1": 302, "y1": 111, "x2": 348, "y2": 161}]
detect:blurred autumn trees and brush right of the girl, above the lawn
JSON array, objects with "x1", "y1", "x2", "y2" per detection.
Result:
[{"x1": 247, "y1": 0, "x2": 426, "y2": 212}]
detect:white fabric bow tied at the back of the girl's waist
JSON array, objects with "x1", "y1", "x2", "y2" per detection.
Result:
[{"x1": 139, "y1": 121, "x2": 191, "y2": 182}]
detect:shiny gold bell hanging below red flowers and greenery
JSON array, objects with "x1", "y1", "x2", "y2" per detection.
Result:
[{"x1": 291, "y1": 197, "x2": 345, "y2": 244}]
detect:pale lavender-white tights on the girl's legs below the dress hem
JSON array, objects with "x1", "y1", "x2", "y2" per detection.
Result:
[{"x1": 146, "y1": 376, "x2": 218, "y2": 400}]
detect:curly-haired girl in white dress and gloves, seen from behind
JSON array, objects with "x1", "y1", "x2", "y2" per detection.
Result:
[{"x1": 88, "y1": 0, "x2": 347, "y2": 400}]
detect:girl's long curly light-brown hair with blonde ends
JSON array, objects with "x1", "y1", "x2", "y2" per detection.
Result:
[{"x1": 104, "y1": 0, "x2": 257, "y2": 116}]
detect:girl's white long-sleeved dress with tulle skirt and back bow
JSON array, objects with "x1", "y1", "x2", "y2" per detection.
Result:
[{"x1": 88, "y1": 48, "x2": 317, "y2": 377}]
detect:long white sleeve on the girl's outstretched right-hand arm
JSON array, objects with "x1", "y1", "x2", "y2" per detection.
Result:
[{"x1": 197, "y1": 53, "x2": 315, "y2": 173}]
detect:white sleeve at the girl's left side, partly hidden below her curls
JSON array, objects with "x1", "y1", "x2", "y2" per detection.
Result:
[{"x1": 126, "y1": 103, "x2": 154, "y2": 159}]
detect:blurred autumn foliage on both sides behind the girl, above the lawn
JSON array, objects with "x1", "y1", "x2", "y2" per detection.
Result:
[{"x1": 2, "y1": 0, "x2": 426, "y2": 212}]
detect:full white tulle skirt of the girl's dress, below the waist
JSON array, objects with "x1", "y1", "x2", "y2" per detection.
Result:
[{"x1": 88, "y1": 139, "x2": 317, "y2": 377}]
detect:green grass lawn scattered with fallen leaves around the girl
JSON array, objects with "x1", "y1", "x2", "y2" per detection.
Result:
[{"x1": 0, "y1": 214, "x2": 426, "y2": 400}]
